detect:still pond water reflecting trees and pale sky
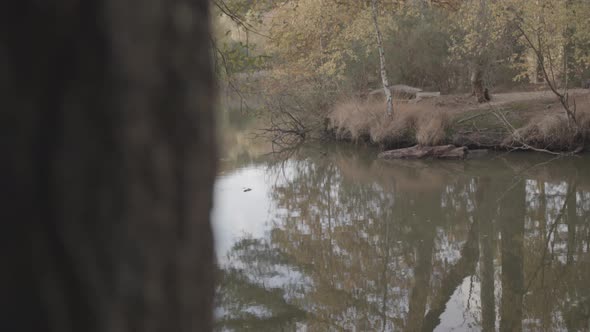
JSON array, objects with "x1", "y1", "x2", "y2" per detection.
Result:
[{"x1": 212, "y1": 119, "x2": 590, "y2": 331}]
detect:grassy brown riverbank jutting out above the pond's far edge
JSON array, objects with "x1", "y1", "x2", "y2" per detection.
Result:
[{"x1": 329, "y1": 89, "x2": 590, "y2": 151}]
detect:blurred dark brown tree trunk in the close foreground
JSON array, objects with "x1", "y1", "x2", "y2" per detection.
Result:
[{"x1": 0, "y1": 0, "x2": 215, "y2": 332}]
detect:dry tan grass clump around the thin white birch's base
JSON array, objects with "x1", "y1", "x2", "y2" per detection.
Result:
[{"x1": 329, "y1": 99, "x2": 449, "y2": 145}]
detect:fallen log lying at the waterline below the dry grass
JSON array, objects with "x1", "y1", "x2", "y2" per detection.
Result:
[{"x1": 378, "y1": 145, "x2": 468, "y2": 159}]
